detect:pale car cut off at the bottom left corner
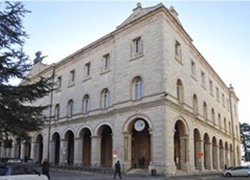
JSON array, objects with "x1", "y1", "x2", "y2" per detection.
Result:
[{"x1": 0, "y1": 164, "x2": 48, "y2": 180}]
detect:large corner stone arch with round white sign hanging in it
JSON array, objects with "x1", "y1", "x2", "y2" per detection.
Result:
[{"x1": 123, "y1": 114, "x2": 153, "y2": 168}]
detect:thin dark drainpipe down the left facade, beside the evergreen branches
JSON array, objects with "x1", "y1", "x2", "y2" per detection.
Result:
[{"x1": 47, "y1": 66, "x2": 55, "y2": 161}]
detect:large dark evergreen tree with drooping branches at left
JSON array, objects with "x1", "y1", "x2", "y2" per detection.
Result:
[{"x1": 0, "y1": 2, "x2": 52, "y2": 142}]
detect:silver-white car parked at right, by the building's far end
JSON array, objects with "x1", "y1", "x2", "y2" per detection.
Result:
[{"x1": 224, "y1": 166, "x2": 250, "y2": 177}]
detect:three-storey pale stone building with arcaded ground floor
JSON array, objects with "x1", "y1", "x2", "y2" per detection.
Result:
[{"x1": 1, "y1": 3, "x2": 241, "y2": 175}]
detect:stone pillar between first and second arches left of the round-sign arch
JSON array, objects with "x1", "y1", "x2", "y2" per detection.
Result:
[{"x1": 91, "y1": 136, "x2": 101, "y2": 166}]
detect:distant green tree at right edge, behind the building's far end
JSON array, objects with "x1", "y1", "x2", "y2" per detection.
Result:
[{"x1": 240, "y1": 123, "x2": 250, "y2": 161}]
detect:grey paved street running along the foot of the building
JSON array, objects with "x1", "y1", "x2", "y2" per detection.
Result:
[{"x1": 47, "y1": 169, "x2": 249, "y2": 180}]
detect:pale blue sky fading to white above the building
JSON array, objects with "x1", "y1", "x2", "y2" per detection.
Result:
[{"x1": 16, "y1": 0, "x2": 250, "y2": 124}]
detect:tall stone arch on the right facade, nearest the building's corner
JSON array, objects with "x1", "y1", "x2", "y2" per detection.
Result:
[{"x1": 173, "y1": 119, "x2": 188, "y2": 170}]
